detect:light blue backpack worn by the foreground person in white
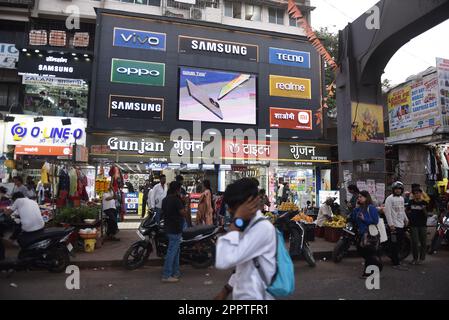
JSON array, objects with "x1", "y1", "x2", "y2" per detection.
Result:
[{"x1": 251, "y1": 218, "x2": 295, "y2": 297}]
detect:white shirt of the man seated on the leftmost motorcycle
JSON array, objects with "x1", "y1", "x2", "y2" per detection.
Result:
[{"x1": 11, "y1": 198, "x2": 45, "y2": 232}]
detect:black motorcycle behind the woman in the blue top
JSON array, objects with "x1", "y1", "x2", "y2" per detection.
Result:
[{"x1": 332, "y1": 219, "x2": 411, "y2": 263}]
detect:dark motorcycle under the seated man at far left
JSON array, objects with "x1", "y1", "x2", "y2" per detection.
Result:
[{"x1": 0, "y1": 214, "x2": 75, "y2": 272}]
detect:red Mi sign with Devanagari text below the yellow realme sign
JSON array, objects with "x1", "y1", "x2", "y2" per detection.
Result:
[{"x1": 270, "y1": 108, "x2": 313, "y2": 130}]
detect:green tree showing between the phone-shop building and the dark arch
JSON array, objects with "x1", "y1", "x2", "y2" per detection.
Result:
[{"x1": 315, "y1": 28, "x2": 338, "y2": 118}]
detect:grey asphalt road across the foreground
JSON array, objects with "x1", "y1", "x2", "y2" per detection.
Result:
[{"x1": 0, "y1": 251, "x2": 449, "y2": 300}]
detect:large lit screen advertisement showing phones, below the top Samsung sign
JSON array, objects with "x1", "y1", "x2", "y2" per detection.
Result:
[{"x1": 179, "y1": 67, "x2": 256, "y2": 125}]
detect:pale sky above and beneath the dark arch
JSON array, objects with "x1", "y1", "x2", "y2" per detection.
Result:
[{"x1": 311, "y1": 0, "x2": 449, "y2": 85}]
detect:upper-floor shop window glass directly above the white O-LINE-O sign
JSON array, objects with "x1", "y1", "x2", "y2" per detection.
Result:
[{"x1": 24, "y1": 83, "x2": 89, "y2": 118}]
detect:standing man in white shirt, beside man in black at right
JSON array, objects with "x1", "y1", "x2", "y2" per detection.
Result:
[{"x1": 385, "y1": 181, "x2": 408, "y2": 271}]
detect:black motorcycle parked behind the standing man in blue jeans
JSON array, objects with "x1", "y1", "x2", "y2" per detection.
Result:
[{"x1": 122, "y1": 214, "x2": 221, "y2": 270}]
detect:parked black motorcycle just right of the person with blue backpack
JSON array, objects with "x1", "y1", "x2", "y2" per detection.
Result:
[{"x1": 274, "y1": 212, "x2": 316, "y2": 267}]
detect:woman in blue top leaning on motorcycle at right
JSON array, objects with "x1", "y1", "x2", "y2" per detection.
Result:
[{"x1": 350, "y1": 191, "x2": 383, "y2": 278}]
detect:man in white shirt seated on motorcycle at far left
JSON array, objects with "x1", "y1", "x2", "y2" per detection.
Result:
[{"x1": 4, "y1": 192, "x2": 45, "y2": 246}]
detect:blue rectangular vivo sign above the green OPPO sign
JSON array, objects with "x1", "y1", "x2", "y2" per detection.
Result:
[{"x1": 113, "y1": 27, "x2": 166, "y2": 51}]
